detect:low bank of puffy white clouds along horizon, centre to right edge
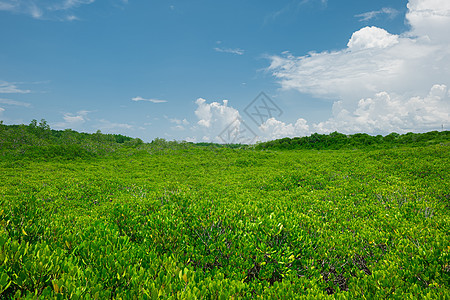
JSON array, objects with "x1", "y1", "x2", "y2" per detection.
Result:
[{"x1": 185, "y1": 84, "x2": 450, "y2": 143}]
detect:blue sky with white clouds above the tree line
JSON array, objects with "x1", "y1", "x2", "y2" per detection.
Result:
[{"x1": 0, "y1": 0, "x2": 450, "y2": 143}]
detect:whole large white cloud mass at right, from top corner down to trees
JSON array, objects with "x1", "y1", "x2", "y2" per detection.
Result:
[{"x1": 269, "y1": 0, "x2": 450, "y2": 133}]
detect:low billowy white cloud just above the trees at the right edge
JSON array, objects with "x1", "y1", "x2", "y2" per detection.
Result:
[{"x1": 313, "y1": 85, "x2": 450, "y2": 134}]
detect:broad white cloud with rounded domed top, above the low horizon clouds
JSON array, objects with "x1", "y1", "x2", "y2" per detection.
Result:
[{"x1": 269, "y1": 27, "x2": 418, "y2": 101}]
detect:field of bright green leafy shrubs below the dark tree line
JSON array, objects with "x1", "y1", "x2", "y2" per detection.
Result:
[{"x1": 0, "y1": 123, "x2": 450, "y2": 299}]
